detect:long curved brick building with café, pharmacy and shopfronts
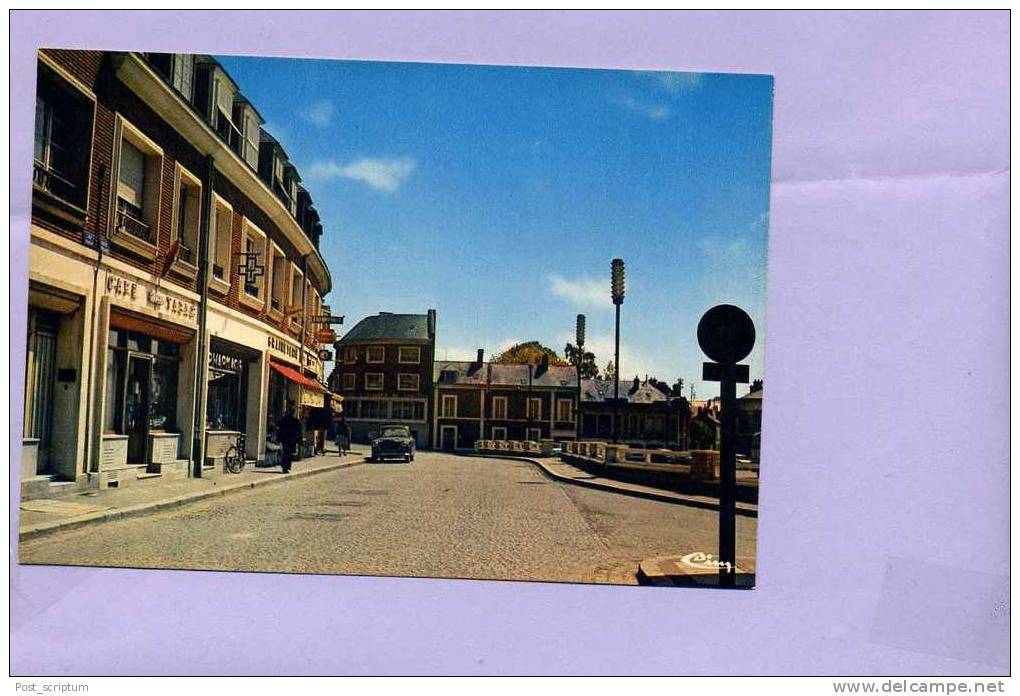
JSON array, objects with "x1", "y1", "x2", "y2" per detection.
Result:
[{"x1": 21, "y1": 50, "x2": 332, "y2": 495}]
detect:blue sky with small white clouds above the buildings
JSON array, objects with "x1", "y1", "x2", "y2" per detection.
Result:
[{"x1": 220, "y1": 57, "x2": 772, "y2": 398}]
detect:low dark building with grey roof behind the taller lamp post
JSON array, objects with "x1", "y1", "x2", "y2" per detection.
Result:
[{"x1": 580, "y1": 378, "x2": 690, "y2": 446}]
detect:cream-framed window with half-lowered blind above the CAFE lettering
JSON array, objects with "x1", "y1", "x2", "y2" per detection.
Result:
[{"x1": 111, "y1": 116, "x2": 163, "y2": 249}]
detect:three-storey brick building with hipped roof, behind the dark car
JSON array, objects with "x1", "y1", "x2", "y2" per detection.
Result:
[{"x1": 329, "y1": 309, "x2": 436, "y2": 447}]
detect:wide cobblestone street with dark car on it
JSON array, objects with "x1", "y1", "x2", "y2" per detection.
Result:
[{"x1": 19, "y1": 452, "x2": 756, "y2": 583}]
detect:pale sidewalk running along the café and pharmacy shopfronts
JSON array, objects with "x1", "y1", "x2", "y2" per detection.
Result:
[{"x1": 18, "y1": 445, "x2": 368, "y2": 541}]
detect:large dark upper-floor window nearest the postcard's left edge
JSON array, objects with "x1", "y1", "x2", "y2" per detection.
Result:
[{"x1": 33, "y1": 62, "x2": 94, "y2": 214}]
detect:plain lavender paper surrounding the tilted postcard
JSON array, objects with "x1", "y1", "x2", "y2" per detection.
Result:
[{"x1": 10, "y1": 11, "x2": 1010, "y2": 675}]
